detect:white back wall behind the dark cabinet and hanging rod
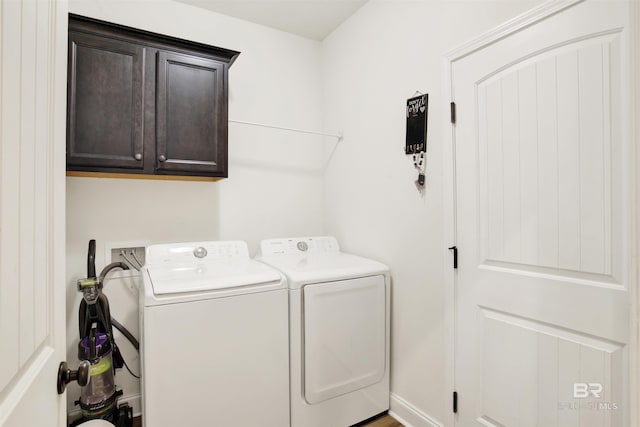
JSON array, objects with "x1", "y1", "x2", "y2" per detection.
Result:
[{"x1": 66, "y1": 0, "x2": 327, "y2": 414}]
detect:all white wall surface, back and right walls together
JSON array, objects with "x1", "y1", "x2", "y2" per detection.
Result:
[{"x1": 67, "y1": 0, "x2": 552, "y2": 425}]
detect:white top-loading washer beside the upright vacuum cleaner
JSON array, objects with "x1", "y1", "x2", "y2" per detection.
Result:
[{"x1": 140, "y1": 241, "x2": 289, "y2": 427}]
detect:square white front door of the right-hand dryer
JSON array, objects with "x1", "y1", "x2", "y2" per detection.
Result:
[{"x1": 303, "y1": 275, "x2": 386, "y2": 404}]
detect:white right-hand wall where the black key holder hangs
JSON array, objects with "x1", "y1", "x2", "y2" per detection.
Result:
[{"x1": 322, "y1": 0, "x2": 540, "y2": 426}]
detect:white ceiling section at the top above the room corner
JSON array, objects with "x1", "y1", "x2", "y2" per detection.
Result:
[{"x1": 176, "y1": 0, "x2": 367, "y2": 40}]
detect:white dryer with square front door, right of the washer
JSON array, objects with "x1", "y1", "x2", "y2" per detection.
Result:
[{"x1": 257, "y1": 237, "x2": 390, "y2": 427}]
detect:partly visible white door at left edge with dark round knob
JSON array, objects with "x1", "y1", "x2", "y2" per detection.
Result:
[{"x1": 0, "y1": 0, "x2": 67, "y2": 427}]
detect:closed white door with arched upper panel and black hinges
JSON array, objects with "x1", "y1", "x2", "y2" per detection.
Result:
[{"x1": 450, "y1": 0, "x2": 635, "y2": 427}]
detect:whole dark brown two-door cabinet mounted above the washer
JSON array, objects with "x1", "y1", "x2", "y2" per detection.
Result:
[{"x1": 67, "y1": 15, "x2": 239, "y2": 178}]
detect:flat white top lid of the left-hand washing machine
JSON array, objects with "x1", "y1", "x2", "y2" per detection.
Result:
[{"x1": 147, "y1": 258, "x2": 281, "y2": 295}]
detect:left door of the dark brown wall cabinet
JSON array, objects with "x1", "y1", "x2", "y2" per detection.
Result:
[{"x1": 67, "y1": 32, "x2": 144, "y2": 172}]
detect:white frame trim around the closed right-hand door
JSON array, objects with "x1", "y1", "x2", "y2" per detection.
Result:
[{"x1": 442, "y1": 0, "x2": 640, "y2": 426}]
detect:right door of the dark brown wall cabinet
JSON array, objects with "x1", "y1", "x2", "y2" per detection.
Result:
[{"x1": 156, "y1": 51, "x2": 227, "y2": 177}]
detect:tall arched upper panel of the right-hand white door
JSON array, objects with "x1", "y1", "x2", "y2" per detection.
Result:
[{"x1": 477, "y1": 32, "x2": 623, "y2": 275}]
